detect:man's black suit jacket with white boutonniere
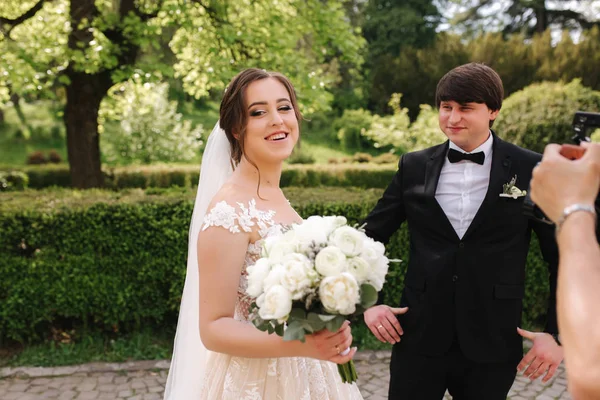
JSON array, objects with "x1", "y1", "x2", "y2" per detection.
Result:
[{"x1": 365, "y1": 135, "x2": 558, "y2": 362}]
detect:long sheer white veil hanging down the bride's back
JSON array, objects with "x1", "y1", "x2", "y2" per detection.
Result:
[{"x1": 164, "y1": 121, "x2": 233, "y2": 400}]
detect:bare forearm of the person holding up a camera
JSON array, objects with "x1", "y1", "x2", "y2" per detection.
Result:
[{"x1": 557, "y1": 212, "x2": 600, "y2": 390}]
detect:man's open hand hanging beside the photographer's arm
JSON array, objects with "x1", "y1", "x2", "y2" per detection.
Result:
[{"x1": 517, "y1": 328, "x2": 564, "y2": 382}]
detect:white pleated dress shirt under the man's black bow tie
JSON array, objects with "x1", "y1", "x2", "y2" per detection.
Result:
[{"x1": 435, "y1": 133, "x2": 494, "y2": 239}]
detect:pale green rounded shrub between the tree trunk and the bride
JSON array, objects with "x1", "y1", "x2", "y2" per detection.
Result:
[{"x1": 99, "y1": 77, "x2": 203, "y2": 164}]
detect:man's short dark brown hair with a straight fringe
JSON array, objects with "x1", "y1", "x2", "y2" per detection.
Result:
[{"x1": 435, "y1": 63, "x2": 504, "y2": 127}]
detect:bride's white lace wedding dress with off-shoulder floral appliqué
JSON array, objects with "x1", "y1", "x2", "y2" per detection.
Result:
[{"x1": 200, "y1": 200, "x2": 362, "y2": 400}]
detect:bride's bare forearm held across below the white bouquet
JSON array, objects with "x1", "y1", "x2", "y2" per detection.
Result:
[{"x1": 201, "y1": 317, "x2": 306, "y2": 358}]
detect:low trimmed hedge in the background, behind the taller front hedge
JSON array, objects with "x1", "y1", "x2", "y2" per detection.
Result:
[{"x1": 0, "y1": 164, "x2": 397, "y2": 189}]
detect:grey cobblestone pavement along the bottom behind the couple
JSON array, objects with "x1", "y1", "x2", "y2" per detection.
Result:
[{"x1": 0, "y1": 351, "x2": 571, "y2": 400}]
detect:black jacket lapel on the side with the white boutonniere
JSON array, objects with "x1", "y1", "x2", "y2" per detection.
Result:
[{"x1": 463, "y1": 135, "x2": 512, "y2": 239}]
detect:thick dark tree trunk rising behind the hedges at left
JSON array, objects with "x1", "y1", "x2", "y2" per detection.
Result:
[{"x1": 64, "y1": 70, "x2": 112, "y2": 189}]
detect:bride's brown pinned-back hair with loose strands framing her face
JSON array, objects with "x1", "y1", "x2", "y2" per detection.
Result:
[{"x1": 219, "y1": 68, "x2": 302, "y2": 166}]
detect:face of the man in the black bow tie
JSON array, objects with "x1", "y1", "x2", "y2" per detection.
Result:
[{"x1": 439, "y1": 100, "x2": 499, "y2": 152}]
